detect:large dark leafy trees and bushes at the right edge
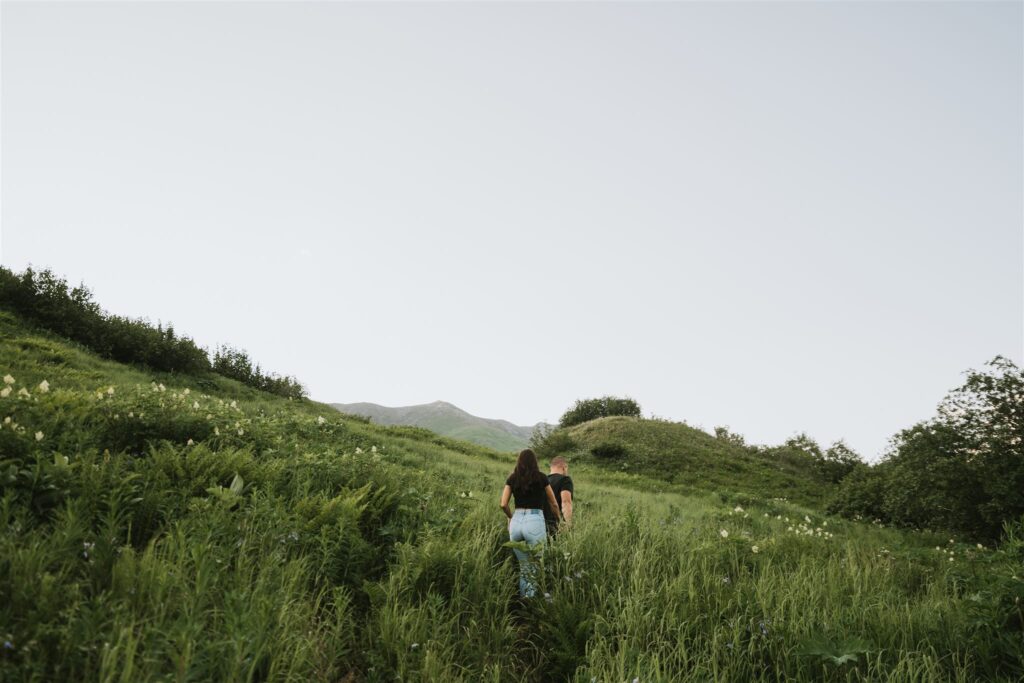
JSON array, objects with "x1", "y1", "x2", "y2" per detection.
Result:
[{"x1": 833, "y1": 357, "x2": 1024, "y2": 540}]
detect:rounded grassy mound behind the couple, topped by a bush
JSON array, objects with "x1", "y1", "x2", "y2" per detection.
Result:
[{"x1": 563, "y1": 417, "x2": 833, "y2": 506}]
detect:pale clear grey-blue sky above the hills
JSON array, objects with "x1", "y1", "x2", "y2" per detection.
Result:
[{"x1": 0, "y1": 2, "x2": 1024, "y2": 459}]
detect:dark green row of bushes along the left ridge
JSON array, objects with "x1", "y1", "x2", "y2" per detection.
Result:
[{"x1": 0, "y1": 266, "x2": 305, "y2": 398}]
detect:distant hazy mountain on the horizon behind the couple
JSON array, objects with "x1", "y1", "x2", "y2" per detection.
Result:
[{"x1": 331, "y1": 400, "x2": 548, "y2": 451}]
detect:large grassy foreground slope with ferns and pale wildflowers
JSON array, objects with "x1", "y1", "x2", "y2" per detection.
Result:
[{"x1": 0, "y1": 312, "x2": 1024, "y2": 683}]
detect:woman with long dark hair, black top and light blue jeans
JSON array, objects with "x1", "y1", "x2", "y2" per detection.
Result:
[{"x1": 500, "y1": 449, "x2": 558, "y2": 598}]
